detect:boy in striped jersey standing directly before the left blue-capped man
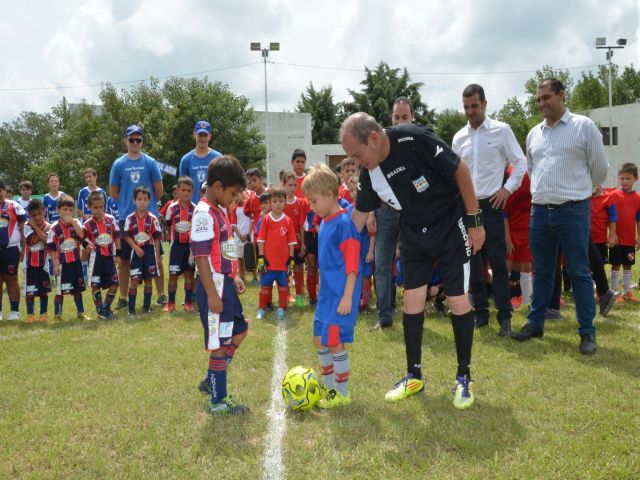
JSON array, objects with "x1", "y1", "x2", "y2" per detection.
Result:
[{"x1": 123, "y1": 186, "x2": 162, "y2": 315}]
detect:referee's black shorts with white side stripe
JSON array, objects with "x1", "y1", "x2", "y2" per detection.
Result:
[{"x1": 400, "y1": 211, "x2": 471, "y2": 297}]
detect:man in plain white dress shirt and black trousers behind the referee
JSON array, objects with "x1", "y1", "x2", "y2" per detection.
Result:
[{"x1": 452, "y1": 83, "x2": 527, "y2": 336}]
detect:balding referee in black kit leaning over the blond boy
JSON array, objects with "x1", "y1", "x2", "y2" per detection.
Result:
[{"x1": 340, "y1": 112, "x2": 485, "y2": 409}]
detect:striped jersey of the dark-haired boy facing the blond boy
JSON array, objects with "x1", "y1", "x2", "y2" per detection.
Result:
[{"x1": 191, "y1": 198, "x2": 238, "y2": 277}]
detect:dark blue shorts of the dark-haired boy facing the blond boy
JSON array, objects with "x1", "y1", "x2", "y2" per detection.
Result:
[{"x1": 196, "y1": 275, "x2": 249, "y2": 351}]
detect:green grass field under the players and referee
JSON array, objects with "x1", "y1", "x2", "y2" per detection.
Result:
[{"x1": 0, "y1": 251, "x2": 640, "y2": 480}]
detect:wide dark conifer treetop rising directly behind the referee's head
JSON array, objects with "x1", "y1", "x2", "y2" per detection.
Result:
[{"x1": 342, "y1": 62, "x2": 435, "y2": 125}]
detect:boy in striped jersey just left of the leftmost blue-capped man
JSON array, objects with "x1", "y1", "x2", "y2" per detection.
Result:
[{"x1": 83, "y1": 190, "x2": 120, "y2": 319}]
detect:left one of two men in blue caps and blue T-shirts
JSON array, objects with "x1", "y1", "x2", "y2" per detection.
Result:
[{"x1": 109, "y1": 125, "x2": 164, "y2": 308}]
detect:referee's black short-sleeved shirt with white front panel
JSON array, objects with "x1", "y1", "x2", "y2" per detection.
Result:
[{"x1": 356, "y1": 124, "x2": 462, "y2": 226}]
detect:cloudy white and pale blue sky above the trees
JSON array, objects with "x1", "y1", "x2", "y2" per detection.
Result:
[{"x1": 0, "y1": 0, "x2": 640, "y2": 122}]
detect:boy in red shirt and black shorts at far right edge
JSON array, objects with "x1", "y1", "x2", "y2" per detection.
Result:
[{"x1": 609, "y1": 163, "x2": 640, "y2": 303}]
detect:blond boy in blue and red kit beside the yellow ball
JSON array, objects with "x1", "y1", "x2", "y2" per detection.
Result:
[{"x1": 302, "y1": 164, "x2": 362, "y2": 408}]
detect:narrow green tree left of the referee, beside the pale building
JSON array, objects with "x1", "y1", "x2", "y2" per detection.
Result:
[{"x1": 296, "y1": 82, "x2": 340, "y2": 144}]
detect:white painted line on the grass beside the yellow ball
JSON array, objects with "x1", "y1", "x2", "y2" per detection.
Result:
[{"x1": 262, "y1": 320, "x2": 287, "y2": 480}]
